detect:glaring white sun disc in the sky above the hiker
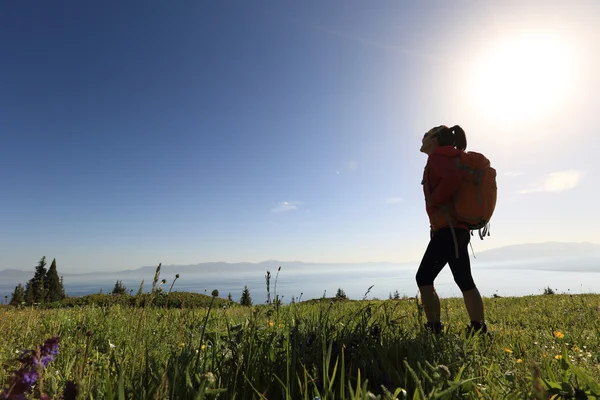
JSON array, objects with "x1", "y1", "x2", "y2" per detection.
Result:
[{"x1": 470, "y1": 34, "x2": 575, "y2": 123}]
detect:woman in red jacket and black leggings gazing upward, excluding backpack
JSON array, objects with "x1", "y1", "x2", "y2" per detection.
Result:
[{"x1": 416, "y1": 125, "x2": 487, "y2": 333}]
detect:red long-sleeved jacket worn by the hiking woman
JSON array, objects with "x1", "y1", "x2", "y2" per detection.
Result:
[{"x1": 422, "y1": 146, "x2": 468, "y2": 230}]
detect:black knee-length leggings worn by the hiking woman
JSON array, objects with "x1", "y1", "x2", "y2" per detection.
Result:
[{"x1": 417, "y1": 228, "x2": 475, "y2": 292}]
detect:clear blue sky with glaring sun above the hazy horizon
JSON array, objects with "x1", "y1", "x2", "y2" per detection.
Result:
[{"x1": 0, "y1": 1, "x2": 600, "y2": 272}]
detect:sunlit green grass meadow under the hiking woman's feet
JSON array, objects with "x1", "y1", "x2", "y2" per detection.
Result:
[{"x1": 0, "y1": 293, "x2": 600, "y2": 400}]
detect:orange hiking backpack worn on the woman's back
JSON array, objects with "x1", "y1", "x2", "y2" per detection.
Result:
[{"x1": 454, "y1": 151, "x2": 498, "y2": 233}]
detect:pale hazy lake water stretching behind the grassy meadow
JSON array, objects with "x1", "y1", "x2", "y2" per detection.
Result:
[{"x1": 0, "y1": 264, "x2": 600, "y2": 304}]
